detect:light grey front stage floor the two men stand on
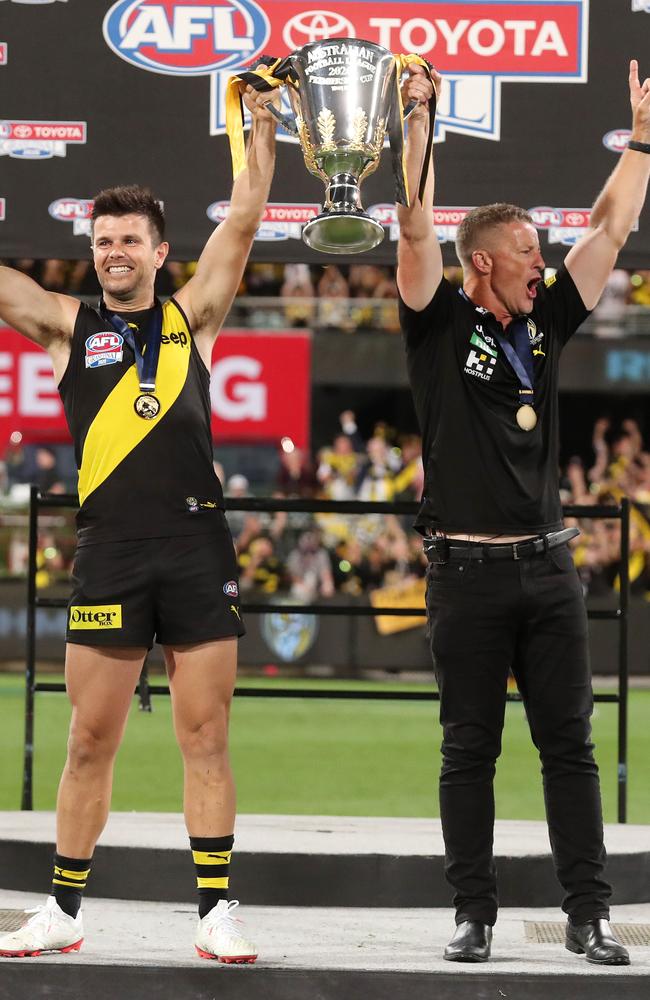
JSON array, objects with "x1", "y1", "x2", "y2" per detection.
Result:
[{"x1": 0, "y1": 891, "x2": 650, "y2": 1000}]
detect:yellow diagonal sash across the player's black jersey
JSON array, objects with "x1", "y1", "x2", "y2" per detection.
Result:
[{"x1": 79, "y1": 299, "x2": 192, "y2": 505}]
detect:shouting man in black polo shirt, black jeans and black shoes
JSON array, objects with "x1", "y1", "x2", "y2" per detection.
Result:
[{"x1": 397, "y1": 60, "x2": 650, "y2": 965}]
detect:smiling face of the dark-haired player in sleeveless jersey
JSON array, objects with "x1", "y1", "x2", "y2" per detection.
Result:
[{"x1": 92, "y1": 213, "x2": 169, "y2": 308}]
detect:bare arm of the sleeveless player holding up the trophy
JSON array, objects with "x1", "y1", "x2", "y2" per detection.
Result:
[{"x1": 176, "y1": 85, "x2": 277, "y2": 359}]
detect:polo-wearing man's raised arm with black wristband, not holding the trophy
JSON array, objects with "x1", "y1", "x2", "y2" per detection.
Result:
[{"x1": 565, "y1": 59, "x2": 650, "y2": 309}]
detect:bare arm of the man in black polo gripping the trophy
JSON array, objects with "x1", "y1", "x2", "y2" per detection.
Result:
[{"x1": 397, "y1": 64, "x2": 442, "y2": 311}]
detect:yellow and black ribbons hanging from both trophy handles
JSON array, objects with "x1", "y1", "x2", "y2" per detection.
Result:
[{"x1": 226, "y1": 53, "x2": 436, "y2": 206}]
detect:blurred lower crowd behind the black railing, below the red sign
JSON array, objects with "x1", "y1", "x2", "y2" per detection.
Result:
[{"x1": 0, "y1": 410, "x2": 650, "y2": 603}]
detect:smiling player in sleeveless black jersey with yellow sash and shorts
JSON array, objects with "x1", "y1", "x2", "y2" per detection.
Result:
[{"x1": 0, "y1": 80, "x2": 276, "y2": 963}]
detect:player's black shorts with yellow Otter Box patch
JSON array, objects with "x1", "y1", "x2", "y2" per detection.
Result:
[{"x1": 66, "y1": 517, "x2": 246, "y2": 648}]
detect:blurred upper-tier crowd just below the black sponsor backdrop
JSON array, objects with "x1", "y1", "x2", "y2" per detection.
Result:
[{"x1": 0, "y1": 259, "x2": 650, "y2": 337}]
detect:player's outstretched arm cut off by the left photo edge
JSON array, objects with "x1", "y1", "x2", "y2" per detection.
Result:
[{"x1": 0, "y1": 267, "x2": 79, "y2": 380}]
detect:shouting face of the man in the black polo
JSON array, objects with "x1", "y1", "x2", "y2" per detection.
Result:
[{"x1": 471, "y1": 221, "x2": 544, "y2": 322}]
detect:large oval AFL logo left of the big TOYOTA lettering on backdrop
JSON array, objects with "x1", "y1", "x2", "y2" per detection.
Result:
[{"x1": 104, "y1": 0, "x2": 270, "y2": 76}]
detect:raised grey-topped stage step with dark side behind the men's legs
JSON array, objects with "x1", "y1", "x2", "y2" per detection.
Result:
[{"x1": 0, "y1": 812, "x2": 650, "y2": 908}]
